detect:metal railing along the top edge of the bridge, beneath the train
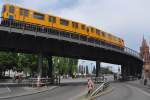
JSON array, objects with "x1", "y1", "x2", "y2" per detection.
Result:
[{"x1": 0, "y1": 17, "x2": 141, "y2": 59}]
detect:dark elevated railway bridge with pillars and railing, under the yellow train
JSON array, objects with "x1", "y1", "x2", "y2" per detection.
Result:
[{"x1": 0, "y1": 17, "x2": 143, "y2": 79}]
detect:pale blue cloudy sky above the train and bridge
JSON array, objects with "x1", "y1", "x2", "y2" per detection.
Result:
[{"x1": 0, "y1": 0, "x2": 150, "y2": 72}]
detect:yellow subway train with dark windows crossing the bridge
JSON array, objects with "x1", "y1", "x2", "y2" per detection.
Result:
[{"x1": 2, "y1": 4, "x2": 124, "y2": 49}]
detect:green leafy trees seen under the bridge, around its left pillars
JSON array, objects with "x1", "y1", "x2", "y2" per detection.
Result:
[{"x1": 0, "y1": 52, "x2": 78, "y2": 76}]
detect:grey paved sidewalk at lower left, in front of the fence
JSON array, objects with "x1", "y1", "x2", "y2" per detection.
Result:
[{"x1": 0, "y1": 86, "x2": 58, "y2": 99}]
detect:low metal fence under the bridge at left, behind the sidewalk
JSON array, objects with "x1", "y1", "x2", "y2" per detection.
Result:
[{"x1": 0, "y1": 77, "x2": 60, "y2": 87}]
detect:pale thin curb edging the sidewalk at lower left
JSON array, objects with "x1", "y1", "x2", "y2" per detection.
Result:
[{"x1": 0, "y1": 86, "x2": 59, "y2": 99}]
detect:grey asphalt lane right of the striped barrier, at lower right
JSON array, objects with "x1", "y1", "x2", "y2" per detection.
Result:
[{"x1": 96, "y1": 83, "x2": 150, "y2": 100}]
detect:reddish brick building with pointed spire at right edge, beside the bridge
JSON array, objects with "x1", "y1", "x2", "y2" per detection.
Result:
[{"x1": 140, "y1": 37, "x2": 150, "y2": 78}]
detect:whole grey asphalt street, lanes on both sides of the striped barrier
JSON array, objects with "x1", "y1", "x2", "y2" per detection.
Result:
[{"x1": 1, "y1": 77, "x2": 150, "y2": 100}]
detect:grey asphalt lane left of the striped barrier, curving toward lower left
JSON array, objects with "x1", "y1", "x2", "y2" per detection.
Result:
[{"x1": 0, "y1": 84, "x2": 87, "y2": 100}]
